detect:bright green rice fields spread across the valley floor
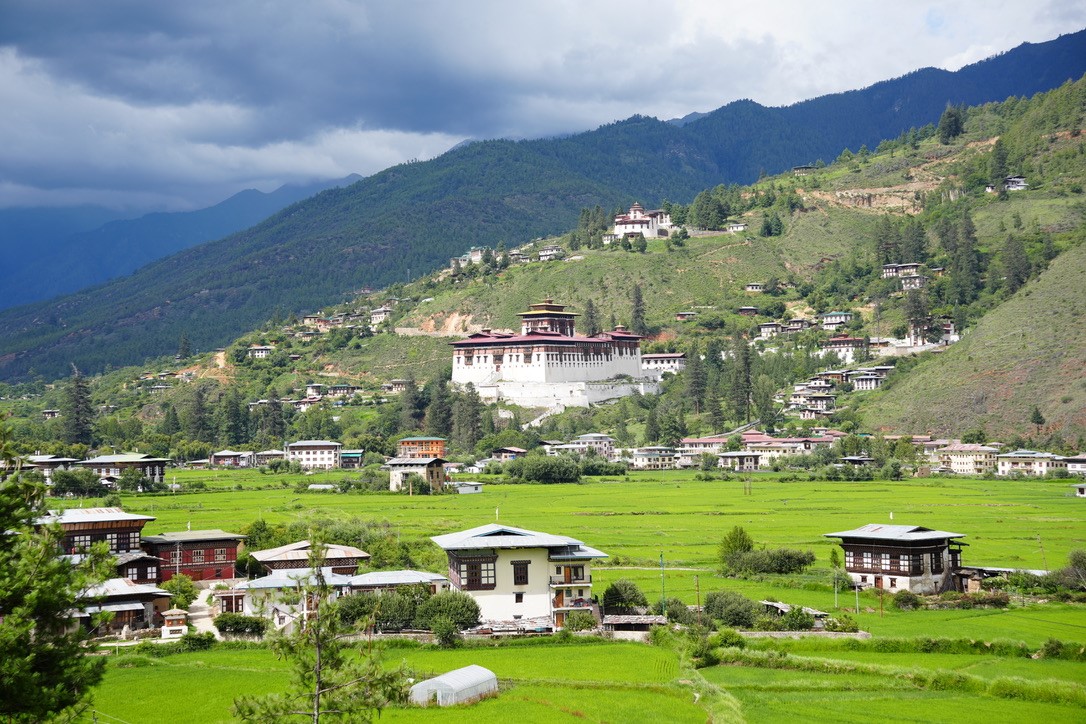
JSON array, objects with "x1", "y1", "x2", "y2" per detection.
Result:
[{"x1": 78, "y1": 471, "x2": 1086, "y2": 724}]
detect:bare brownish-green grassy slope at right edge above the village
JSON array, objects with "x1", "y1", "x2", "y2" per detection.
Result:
[{"x1": 863, "y1": 240, "x2": 1086, "y2": 439}]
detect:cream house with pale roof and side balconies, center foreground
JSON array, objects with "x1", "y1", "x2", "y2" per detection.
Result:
[{"x1": 430, "y1": 523, "x2": 607, "y2": 628}]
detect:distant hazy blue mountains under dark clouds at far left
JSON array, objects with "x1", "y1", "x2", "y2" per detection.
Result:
[{"x1": 0, "y1": 175, "x2": 362, "y2": 309}]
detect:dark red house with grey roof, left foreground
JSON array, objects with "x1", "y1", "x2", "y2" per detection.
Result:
[{"x1": 143, "y1": 530, "x2": 245, "y2": 582}]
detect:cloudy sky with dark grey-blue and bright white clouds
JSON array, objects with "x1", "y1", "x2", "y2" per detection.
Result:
[{"x1": 0, "y1": 0, "x2": 1086, "y2": 213}]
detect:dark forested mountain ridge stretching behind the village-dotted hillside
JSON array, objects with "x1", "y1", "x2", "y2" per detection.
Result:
[{"x1": 0, "y1": 31, "x2": 1086, "y2": 379}]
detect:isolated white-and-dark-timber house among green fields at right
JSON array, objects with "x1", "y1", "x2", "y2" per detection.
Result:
[{"x1": 824, "y1": 523, "x2": 965, "y2": 595}]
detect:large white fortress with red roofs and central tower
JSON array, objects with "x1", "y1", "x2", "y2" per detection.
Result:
[{"x1": 451, "y1": 299, "x2": 659, "y2": 407}]
